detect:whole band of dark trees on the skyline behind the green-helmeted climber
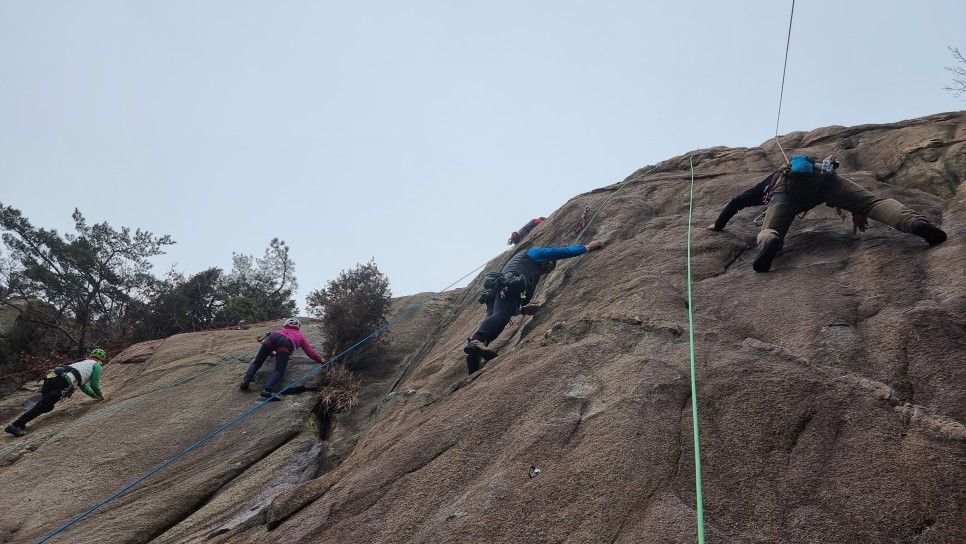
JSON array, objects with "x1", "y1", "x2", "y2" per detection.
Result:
[{"x1": 0, "y1": 203, "x2": 298, "y2": 362}]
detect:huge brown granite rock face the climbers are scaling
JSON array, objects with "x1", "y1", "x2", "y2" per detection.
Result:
[{"x1": 0, "y1": 112, "x2": 966, "y2": 544}]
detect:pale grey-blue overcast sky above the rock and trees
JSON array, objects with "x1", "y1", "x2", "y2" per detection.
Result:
[{"x1": 0, "y1": 0, "x2": 966, "y2": 308}]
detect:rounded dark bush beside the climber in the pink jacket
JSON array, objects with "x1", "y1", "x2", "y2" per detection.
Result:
[{"x1": 306, "y1": 261, "x2": 392, "y2": 358}]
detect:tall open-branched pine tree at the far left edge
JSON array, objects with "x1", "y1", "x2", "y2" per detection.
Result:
[{"x1": 0, "y1": 204, "x2": 174, "y2": 353}]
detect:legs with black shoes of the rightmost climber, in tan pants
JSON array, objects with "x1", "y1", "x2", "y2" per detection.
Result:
[{"x1": 753, "y1": 172, "x2": 946, "y2": 272}]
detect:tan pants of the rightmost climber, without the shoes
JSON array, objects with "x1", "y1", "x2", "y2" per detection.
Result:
[{"x1": 758, "y1": 174, "x2": 925, "y2": 248}]
